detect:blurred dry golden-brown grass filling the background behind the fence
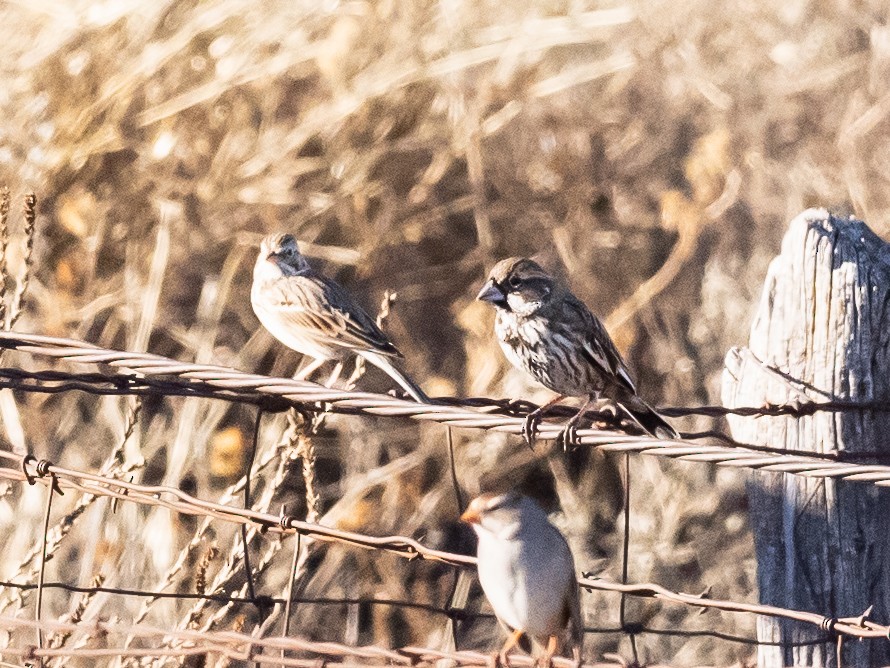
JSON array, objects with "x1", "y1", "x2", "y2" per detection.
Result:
[{"x1": 0, "y1": 0, "x2": 890, "y2": 665}]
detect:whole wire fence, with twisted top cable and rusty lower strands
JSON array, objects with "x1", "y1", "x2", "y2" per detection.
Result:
[{"x1": 0, "y1": 332, "x2": 890, "y2": 666}]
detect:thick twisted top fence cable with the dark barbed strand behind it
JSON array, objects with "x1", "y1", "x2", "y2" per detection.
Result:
[{"x1": 0, "y1": 332, "x2": 890, "y2": 486}]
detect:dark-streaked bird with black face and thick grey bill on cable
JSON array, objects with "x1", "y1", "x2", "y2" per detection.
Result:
[{"x1": 476, "y1": 257, "x2": 679, "y2": 446}]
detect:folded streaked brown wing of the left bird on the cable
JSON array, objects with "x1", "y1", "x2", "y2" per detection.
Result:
[{"x1": 266, "y1": 275, "x2": 402, "y2": 357}]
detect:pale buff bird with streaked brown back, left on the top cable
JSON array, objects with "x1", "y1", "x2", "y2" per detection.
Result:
[{"x1": 250, "y1": 234, "x2": 429, "y2": 403}]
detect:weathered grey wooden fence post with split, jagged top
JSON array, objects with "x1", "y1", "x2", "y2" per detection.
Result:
[{"x1": 722, "y1": 209, "x2": 890, "y2": 668}]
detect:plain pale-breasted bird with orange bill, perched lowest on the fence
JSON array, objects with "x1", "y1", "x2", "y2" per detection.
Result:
[{"x1": 460, "y1": 491, "x2": 584, "y2": 664}]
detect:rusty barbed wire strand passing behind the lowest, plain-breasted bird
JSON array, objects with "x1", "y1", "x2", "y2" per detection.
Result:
[{"x1": 0, "y1": 451, "x2": 890, "y2": 642}]
